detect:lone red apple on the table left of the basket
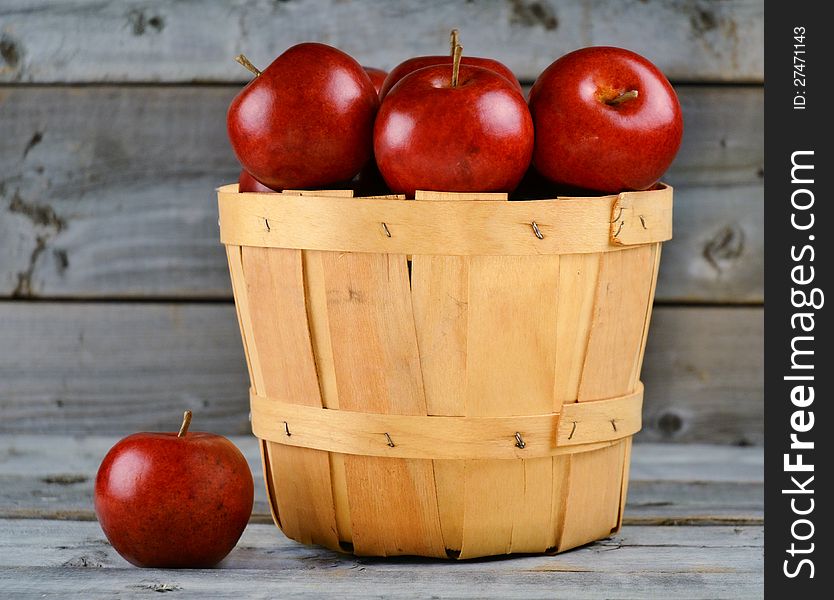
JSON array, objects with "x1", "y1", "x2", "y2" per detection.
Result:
[{"x1": 95, "y1": 432, "x2": 254, "y2": 568}]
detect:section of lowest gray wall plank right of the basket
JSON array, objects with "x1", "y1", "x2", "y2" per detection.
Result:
[{"x1": 638, "y1": 307, "x2": 764, "y2": 446}]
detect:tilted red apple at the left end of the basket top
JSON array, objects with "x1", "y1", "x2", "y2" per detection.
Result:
[{"x1": 226, "y1": 43, "x2": 379, "y2": 189}]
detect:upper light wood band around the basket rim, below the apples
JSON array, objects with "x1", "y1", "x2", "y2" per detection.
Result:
[{"x1": 217, "y1": 184, "x2": 672, "y2": 256}]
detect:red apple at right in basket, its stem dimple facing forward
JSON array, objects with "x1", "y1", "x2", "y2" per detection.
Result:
[{"x1": 530, "y1": 46, "x2": 683, "y2": 193}]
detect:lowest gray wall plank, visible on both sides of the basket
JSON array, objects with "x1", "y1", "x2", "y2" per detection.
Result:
[{"x1": 0, "y1": 302, "x2": 763, "y2": 444}]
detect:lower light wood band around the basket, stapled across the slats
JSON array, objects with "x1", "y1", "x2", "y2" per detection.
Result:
[{"x1": 250, "y1": 383, "x2": 643, "y2": 459}]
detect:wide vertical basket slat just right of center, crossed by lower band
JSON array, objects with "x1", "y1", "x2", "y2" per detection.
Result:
[{"x1": 461, "y1": 256, "x2": 560, "y2": 558}]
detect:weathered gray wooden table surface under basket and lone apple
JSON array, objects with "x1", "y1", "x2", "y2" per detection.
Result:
[{"x1": 0, "y1": 435, "x2": 763, "y2": 599}]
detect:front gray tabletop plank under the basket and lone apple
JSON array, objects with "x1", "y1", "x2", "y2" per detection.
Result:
[{"x1": 0, "y1": 520, "x2": 763, "y2": 599}]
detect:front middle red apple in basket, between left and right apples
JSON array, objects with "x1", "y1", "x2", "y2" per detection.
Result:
[{"x1": 374, "y1": 65, "x2": 533, "y2": 197}]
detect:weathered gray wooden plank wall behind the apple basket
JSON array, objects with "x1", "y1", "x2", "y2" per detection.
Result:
[{"x1": 0, "y1": 0, "x2": 764, "y2": 444}]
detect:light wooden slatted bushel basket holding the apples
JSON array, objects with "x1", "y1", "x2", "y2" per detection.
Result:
[{"x1": 218, "y1": 184, "x2": 672, "y2": 558}]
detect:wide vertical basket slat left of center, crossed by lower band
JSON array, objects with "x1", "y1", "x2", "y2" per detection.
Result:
[{"x1": 321, "y1": 252, "x2": 446, "y2": 557}]
